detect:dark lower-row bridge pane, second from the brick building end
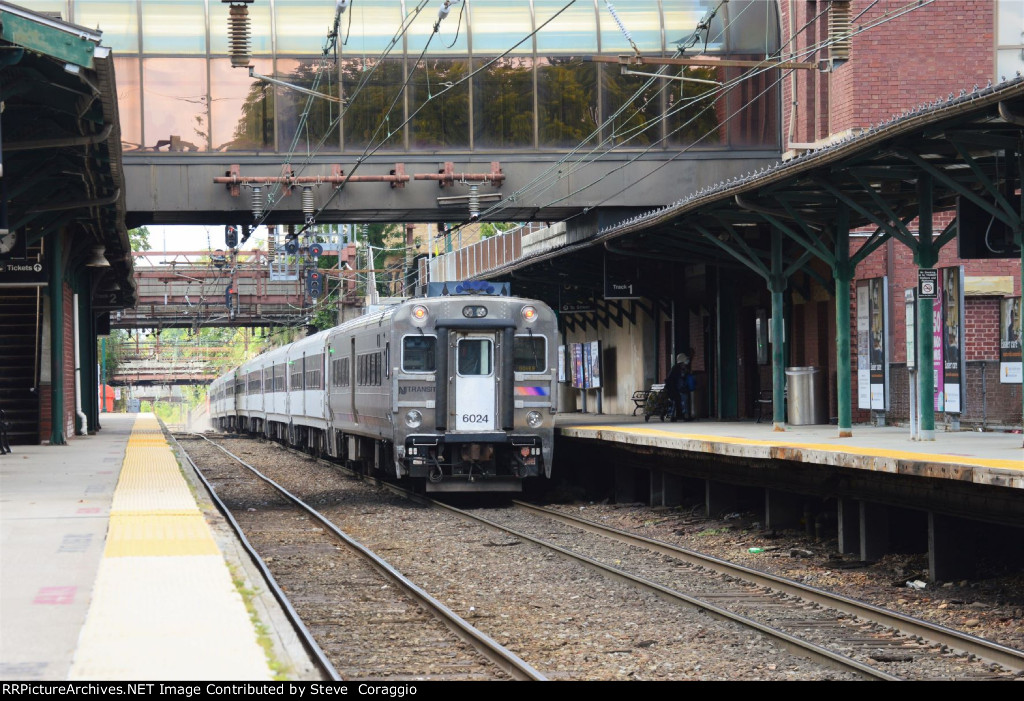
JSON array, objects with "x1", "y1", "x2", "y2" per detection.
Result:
[{"x1": 667, "y1": 65, "x2": 727, "y2": 147}]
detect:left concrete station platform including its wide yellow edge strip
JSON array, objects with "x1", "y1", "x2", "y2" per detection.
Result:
[{"x1": 0, "y1": 413, "x2": 296, "y2": 682}]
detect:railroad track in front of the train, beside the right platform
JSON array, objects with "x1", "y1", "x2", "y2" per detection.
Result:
[{"x1": 456, "y1": 501, "x2": 1024, "y2": 680}]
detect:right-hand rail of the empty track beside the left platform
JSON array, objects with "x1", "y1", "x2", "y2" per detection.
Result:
[{"x1": 180, "y1": 434, "x2": 547, "y2": 682}]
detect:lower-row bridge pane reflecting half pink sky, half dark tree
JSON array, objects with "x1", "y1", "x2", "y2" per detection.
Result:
[{"x1": 210, "y1": 58, "x2": 273, "y2": 150}]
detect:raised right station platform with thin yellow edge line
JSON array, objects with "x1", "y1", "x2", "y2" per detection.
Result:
[{"x1": 556, "y1": 413, "x2": 1024, "y2": 489}]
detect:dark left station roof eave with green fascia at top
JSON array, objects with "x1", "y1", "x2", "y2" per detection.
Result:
[{"x1": 0, "y1": 2, "x2": 137, "y2": 311}]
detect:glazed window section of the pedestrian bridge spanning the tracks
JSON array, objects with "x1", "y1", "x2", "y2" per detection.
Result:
[{"x1": 36, "y1": 0, "x2": 779, "y2": 154}]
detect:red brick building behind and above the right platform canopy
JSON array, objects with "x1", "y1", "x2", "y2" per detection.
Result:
[{"x1": 762, "y1": 0, "x2": 1024, "y2": 428}]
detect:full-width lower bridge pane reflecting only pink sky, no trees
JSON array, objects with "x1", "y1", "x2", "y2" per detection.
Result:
[{"x1": 142, "y1": 58, "x2": 209, "y2": 151}]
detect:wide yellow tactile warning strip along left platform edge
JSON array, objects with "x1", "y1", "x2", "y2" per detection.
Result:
[{"x1": 69, "y1": 414, "x2": 271, "y2": 681}]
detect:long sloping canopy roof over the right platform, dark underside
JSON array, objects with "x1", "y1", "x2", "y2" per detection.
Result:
[{"x1": 488, "y1": 76, "x2": 1024, "y2": 294}]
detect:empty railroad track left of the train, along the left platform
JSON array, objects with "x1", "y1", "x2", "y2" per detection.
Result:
[{"x1": 172, "y1": 434, "x2": 545, "y2": 681}]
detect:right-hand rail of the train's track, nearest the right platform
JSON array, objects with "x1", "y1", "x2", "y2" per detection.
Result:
[{"x1": 513, "y1": 500, "x2": 1024, "y2": 671}]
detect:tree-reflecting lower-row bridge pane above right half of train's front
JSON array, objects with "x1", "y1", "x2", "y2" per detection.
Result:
[{"x1": 473, "y1": 56, "x2": 534, "y2": 149}]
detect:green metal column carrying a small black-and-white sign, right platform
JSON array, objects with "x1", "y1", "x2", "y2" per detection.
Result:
[{"x1": 914, "y1": 173, "x2": 939, "y2": 441}]
